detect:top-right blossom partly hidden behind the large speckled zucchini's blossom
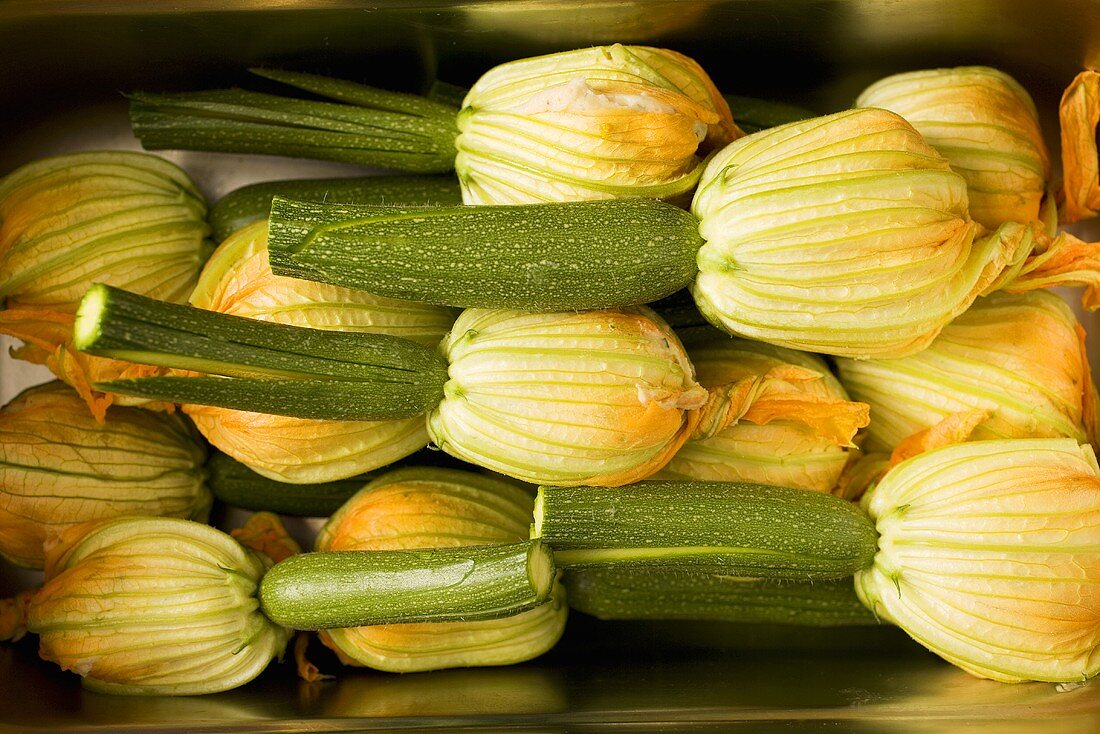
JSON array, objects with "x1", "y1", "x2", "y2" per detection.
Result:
[{"x1": 856, "y1": 66, "x2": 1051, "y2": 229}]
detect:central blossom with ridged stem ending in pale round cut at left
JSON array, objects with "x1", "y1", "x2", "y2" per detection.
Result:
[{"x1": 77, "y1": 286, "x2": 755, "y2": 484}]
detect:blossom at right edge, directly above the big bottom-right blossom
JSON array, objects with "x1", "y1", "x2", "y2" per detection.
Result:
[{"x1": 837, "y1": 291, "x2": 1098, "y2": 451}]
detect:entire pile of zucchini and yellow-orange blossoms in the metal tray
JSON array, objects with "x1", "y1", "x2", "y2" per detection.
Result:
[{"x1": 0, "y1": 44, "x2": 1100, "y2": 694}]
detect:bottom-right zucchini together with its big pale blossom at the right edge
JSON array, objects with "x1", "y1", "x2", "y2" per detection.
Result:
[{"x1": 535, "y1": 439, "x2": 1100, "y2": 682}]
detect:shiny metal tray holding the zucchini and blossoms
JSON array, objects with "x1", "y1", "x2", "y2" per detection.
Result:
[{"x1": 0, "y1": 0, "x2": 1100, "y2": 734}]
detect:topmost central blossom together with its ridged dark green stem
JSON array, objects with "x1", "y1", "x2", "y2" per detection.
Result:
[{"x1": 131, "y1": 44, "x2": 740, "y2": 204}]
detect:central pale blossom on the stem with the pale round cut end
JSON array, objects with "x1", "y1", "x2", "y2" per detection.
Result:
[{"x1": 428, "y1": 307, "x2": 708, "y2": 486}]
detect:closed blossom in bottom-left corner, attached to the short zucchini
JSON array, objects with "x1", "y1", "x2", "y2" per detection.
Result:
[{"x1": 28, "y1": 517, "x2": 292, "y2": 695}]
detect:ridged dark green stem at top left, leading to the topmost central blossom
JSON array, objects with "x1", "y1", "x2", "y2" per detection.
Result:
[{"x1": 130, "y1": 69, "x2": 459, "y2": 173}]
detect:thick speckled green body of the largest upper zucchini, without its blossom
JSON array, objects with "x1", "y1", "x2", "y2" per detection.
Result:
[{"x1": 268, "y1": 197, "x2": 703, "y2": 311}]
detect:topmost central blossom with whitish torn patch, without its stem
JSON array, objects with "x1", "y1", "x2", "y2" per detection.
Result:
[{"x1": 454, "y1": 44, "x2": 741, "y2": 204}]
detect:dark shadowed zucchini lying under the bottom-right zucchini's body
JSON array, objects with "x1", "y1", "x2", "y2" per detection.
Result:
[{"x1": 563, "y1": 568, "x2": 878, "y2": 627}]
